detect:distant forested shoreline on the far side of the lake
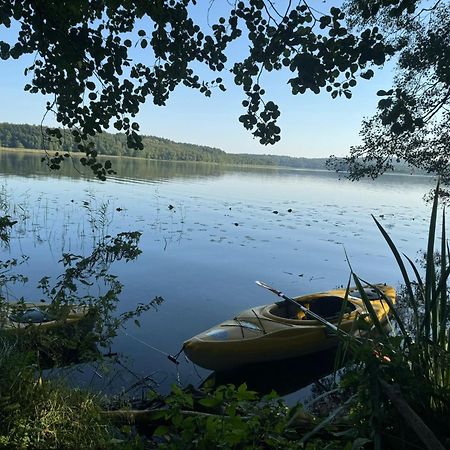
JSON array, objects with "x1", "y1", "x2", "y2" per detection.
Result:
[{"x1": 0, "y1": 123, "x2": 327, "y2": 169}]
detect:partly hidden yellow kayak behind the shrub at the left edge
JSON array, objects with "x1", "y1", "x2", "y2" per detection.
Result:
[{"x1": 0, "y1": 302, "x2": 89, "y2": 332}]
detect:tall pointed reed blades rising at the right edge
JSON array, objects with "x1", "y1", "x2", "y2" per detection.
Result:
[{"x1": 374, "y1": 185, "x2": 450, "y2": 404}]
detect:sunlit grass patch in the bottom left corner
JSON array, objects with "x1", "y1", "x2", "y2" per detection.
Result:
[{"x1": 0, "y1": 340, "x2": 109, "y2": 449}]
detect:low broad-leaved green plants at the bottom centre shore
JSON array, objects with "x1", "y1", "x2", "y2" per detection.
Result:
[{"x1": 148, "y1": 384, "x2": 348, "y2": 450}]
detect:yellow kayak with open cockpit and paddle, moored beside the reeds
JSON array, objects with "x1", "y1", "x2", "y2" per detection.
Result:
[{"x1": 183, "y1": 284, "x2": 395, "y2": 371}]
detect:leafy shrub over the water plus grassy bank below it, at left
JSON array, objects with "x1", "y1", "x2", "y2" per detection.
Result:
[{"x1": 0, "y1": 216, "x2": 162, "y2": 449}]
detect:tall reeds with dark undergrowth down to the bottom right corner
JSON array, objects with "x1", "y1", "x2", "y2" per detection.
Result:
[{"x1": 342, "y1": 184, "x2": 450, "y2": 449}]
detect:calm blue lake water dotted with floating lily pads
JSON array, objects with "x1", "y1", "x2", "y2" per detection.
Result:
[{"x1": 0, "y1": 152, "x2": 435, "y2": 400}]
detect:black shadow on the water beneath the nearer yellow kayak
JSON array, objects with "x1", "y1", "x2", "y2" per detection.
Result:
[{"x1": 202, "y1": 348, "x2": 337, "y2": 395}]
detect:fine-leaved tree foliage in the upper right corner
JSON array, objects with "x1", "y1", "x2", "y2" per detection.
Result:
[{"x1": 332, "y1": 0, "x2": 450, "y2": 183}]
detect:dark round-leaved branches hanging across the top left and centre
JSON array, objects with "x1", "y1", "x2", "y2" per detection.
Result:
[{"x1": 0, "y1": 0, "x2": 394, "y2": 179}]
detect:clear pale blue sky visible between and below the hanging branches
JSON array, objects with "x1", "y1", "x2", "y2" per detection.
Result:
[{"x1": 0, "y1": 2, "x2": 392, "y2": 157}]
